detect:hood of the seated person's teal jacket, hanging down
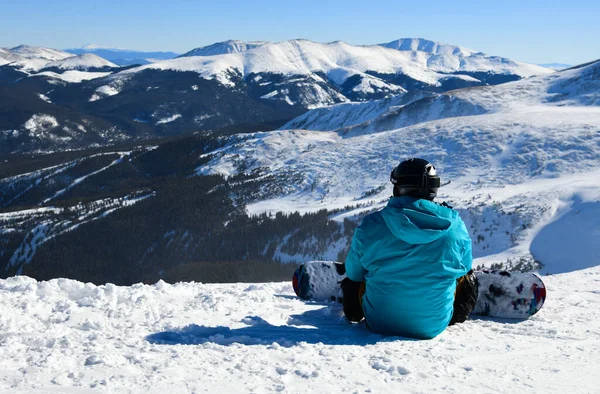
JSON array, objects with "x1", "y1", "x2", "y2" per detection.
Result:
[{"x1": 381, "y1": 196, "x2": 459, "y2": 245}]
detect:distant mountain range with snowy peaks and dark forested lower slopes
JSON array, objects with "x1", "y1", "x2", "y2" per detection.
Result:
[{"x1": 0, "y1": 39, "x2": 553, "y2": 153}]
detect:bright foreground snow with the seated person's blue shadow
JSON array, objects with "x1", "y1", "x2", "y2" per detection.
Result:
[{"x1": 0, "y1": 267, "x2": 600, "y2": 393}]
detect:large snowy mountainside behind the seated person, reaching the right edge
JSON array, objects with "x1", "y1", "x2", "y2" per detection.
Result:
[{"x1": 198, "y1": 61, "x2": 600, "y2": 272}]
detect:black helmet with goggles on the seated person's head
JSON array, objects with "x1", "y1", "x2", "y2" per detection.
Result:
[{"x1": 390, "y1": 158, "x2": 440, "y2": 200}]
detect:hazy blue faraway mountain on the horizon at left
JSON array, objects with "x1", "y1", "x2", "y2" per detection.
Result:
[{"x1": 65, "y1": 44, "x2": 178, "y2": 66}]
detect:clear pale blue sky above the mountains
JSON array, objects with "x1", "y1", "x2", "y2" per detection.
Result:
[{"x1": 0, "y1": 0, "x2": 600, "y2": 64}]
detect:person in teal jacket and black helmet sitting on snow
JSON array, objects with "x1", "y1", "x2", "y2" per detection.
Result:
[{"x1": 341, "y1": 158, "x2": 478, "y2": 339}]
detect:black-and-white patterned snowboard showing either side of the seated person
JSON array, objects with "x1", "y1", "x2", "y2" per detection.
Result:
[{"x1": 292, "y1": 261, "x2": 546, "y2": 319}]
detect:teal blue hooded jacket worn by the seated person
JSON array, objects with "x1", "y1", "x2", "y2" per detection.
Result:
[{"x1": 346, "y1": 196, "x2": 473, "y2": 339}]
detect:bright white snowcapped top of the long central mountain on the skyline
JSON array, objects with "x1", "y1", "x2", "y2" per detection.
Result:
[{"x1": 128, "y1": 40, "x2": 552, "y2": 95}]
